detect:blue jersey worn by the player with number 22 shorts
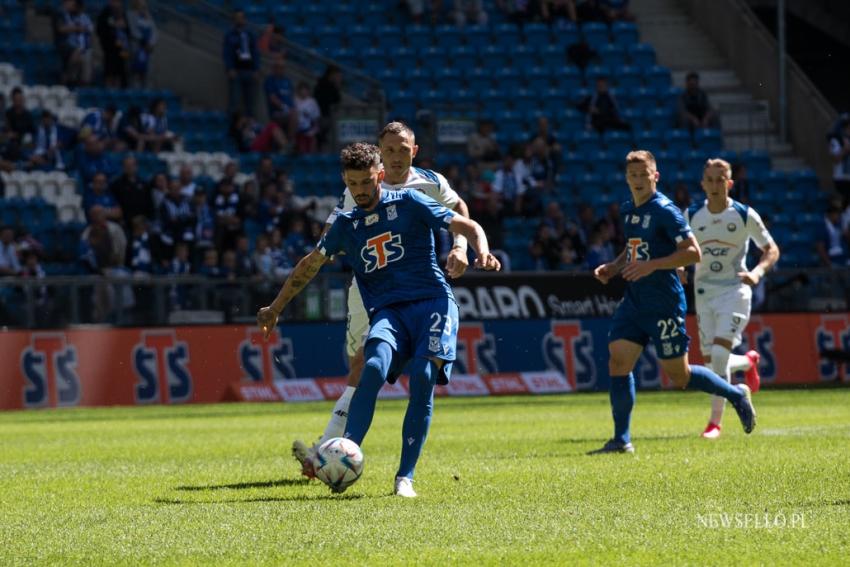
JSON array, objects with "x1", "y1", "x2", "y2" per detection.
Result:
[{"x1": 621, "y1": 192, "x2": 691, "y2": 312}]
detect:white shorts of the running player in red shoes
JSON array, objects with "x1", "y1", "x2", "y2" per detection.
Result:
[{"x1": 696, "y1": 285, "x2": 753, "y2": 356}]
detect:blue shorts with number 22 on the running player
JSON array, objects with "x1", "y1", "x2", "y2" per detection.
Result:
[{"x1": 608, "y1": 299, "x2": 691, "y2": 358}]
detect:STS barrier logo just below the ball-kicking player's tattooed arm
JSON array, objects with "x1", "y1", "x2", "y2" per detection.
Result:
[{"x1": 239, "y1": 328, "x2": 295, "y2": 382}]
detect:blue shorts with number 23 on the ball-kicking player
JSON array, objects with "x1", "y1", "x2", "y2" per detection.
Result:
[{"x1": 366, "y1": 297, "x2": 458, "y2": 384}]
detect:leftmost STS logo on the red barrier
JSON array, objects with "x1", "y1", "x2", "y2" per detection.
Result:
[{"x1": 21, "y1": 333, "x2": 80, "y2": 408}]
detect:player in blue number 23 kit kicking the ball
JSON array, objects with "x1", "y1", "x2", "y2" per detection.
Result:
[{"x1": 257, "y1": 143, "x2": 501, "y2": 497}]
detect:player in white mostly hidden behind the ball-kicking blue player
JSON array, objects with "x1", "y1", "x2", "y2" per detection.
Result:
[{"x1": 292, "y1": 122, "x2": 469, "y2": 477}]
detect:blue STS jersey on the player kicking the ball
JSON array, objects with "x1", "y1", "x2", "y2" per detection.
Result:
[{"x1": 317, "y1": 189, "x2": 455, "y2": 314}]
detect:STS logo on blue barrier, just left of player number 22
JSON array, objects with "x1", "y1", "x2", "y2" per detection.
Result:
[{"x1": 543, "y1": 320, "x2": 596, "y2": 390}]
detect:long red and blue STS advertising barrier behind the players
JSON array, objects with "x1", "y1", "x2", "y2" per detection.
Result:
[{"x1": 0, "y1": 312, "x2": 850, "y2": 410}]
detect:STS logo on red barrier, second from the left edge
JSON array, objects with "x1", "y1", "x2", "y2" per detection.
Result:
[{"x1": 132, "y1": 331, "x2": 192, "y2": 404}]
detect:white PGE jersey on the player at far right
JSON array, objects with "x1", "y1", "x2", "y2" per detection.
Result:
[{"x1": 685, "y1": 199, "x2": 773, "y2": 296}]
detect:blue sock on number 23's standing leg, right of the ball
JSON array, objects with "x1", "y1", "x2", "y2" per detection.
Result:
[{"x1": 396, "y1": 358, "x2": 438, "y2": 478}]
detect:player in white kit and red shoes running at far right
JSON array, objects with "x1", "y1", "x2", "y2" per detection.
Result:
[{"x1": 685, "y1": 159, "x2": 779, "y2": 439}]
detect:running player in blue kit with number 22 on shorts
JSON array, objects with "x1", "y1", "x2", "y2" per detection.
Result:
[{"x1": 591, "y1": 151, "x2": 756, "y2": 454}]
